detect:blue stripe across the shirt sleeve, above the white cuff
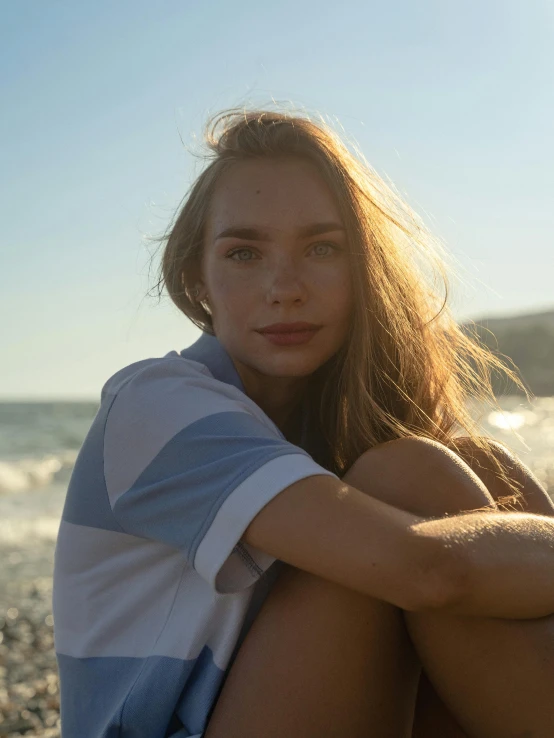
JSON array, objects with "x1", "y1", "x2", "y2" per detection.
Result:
[{"x1": 113, "y1": 412, "x2": 310, "y2": 564}]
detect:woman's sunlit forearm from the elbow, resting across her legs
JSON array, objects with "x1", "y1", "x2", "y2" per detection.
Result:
[{"x1": 413, "y1": 512, "x2": 554, "y2": 619}]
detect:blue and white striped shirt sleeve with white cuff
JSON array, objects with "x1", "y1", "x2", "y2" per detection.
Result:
[{"x1": 104, "y1": 358, "x2": 336, "y2": 593}]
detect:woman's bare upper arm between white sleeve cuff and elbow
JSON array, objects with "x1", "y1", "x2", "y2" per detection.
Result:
[{"x1": 242, "y1": 475, "x2": 452, "y2": 610}]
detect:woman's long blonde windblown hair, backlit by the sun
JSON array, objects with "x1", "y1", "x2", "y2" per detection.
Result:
[{"x1": 149, "y1": 109, "x2": 527, "y2": 499}]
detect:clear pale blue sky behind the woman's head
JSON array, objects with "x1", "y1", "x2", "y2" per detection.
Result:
[{"x1": 0, "y1": 0, "x2": 554, "y2": 399}]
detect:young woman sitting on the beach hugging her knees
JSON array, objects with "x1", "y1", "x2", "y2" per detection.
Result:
[{"x1": 54, "y1": 111, "x2": 554, "y2": 738}]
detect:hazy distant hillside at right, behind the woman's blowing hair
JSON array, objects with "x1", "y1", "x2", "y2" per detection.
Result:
[{"x1": 462, "y1": 310, "x2": 554, "y2": 397}]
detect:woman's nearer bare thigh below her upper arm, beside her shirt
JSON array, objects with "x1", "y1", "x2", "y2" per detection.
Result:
[{"x1": 206, "y1": 566, "x2": 420, "y2": 738}]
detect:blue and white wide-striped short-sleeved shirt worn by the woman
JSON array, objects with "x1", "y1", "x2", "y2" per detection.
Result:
[{"x1": 53, "y1": 333, "x2": 335, "y2": 738}]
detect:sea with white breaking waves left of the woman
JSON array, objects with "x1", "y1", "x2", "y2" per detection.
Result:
[{"x1": 0, "y1": 402, "x2": 98, "y2": 588}]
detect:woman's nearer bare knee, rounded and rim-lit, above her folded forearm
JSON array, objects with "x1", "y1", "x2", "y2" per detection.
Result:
[{"x1": 343, "y1": 437, "x2": 496, "y2": 517}]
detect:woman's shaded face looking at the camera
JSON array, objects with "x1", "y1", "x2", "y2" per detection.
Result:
[{"x1": 199, "y1": 158, "x2": 353, "y2": 380}]
